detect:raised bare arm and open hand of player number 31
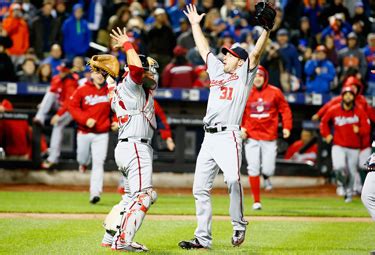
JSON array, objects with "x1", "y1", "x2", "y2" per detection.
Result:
[{"x1": 184, "y1": 4, "x2": 210, "y2": 62}]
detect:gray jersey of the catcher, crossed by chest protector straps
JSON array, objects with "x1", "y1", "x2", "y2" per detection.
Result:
[{"x1": 111, "y1": 73, "x2": 156, "y2": 139}]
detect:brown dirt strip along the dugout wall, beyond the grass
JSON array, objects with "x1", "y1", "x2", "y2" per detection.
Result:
[{"x1": 0, "y1": 184, "x2": 336, "y2": 197}]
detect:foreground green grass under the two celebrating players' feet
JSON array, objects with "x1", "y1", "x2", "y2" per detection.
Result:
[{"x1": 0, "y1": 217, "x2": 375, "y2": 255}]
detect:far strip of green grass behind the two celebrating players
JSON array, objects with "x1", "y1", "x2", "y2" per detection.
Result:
[{"x1": 0, "y1": 192, "x2": 369, "y2": 217}]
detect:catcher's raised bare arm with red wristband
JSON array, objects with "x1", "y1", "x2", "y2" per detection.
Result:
[{"x1": 110, "y1": 27, "x2": 142, "y2": 68}]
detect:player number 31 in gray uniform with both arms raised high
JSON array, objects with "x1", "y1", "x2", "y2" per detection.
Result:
[{"x1": 178, "y1": 2, "x2": 274, "y2": 249}]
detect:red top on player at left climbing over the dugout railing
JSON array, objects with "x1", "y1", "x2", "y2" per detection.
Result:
[{"x1": 49, "y1": 75, "x2": 78, "y2": 116}]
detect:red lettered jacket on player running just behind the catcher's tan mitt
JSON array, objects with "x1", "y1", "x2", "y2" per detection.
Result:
[{"x1": 69, "y1": 81, "x2": 111, "y2": 133}]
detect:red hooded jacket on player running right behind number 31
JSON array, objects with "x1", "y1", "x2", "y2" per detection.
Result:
[{"x1": 241, "y1": 66, "x2": 292, "y2": 141}]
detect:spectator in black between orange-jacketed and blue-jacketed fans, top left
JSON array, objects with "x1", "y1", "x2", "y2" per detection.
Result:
[{"x1": 30, "y1": 0, "x2": 60, "y2": 59}]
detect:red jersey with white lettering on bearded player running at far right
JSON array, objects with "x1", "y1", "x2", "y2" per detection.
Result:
[{"x1": 320, "y1": 104, "x2": 370, "y2": 149}]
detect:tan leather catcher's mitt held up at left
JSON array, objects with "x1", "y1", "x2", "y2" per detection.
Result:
[{"x1": 87, "y1": 54, "x2": 120, "y2": 79}]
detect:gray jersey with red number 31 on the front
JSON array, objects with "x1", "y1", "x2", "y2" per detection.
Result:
[{"x1": 203, "y1": 52, "x2": 258, "y2": 126}]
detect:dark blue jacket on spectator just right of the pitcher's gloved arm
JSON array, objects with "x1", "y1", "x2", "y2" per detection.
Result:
[{"x1": 279, "y1": 43, "x2": 302, "y2": 79}]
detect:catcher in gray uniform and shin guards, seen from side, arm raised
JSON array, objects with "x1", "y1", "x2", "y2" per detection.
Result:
[{"x1": 102, "y1": 28, "x2": 158, "y2": 252}]
